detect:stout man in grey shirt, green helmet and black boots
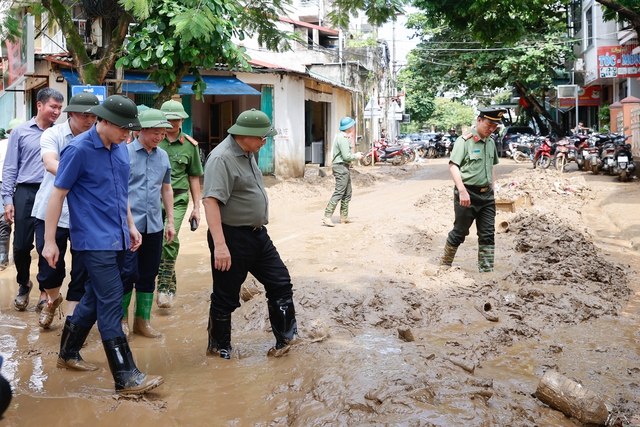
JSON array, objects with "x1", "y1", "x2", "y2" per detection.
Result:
[{"x1": 202, "y1": 109, "x2": 297, "y2": 359}]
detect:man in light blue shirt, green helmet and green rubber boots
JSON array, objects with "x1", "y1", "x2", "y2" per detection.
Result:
[{"x1": 122, "y1": 109, "x2": 176, "y2": 338}]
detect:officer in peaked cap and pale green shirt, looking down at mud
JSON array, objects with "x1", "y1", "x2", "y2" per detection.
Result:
[{"x1": 440, "y1": 108, "x2": 506, "y2": 273}]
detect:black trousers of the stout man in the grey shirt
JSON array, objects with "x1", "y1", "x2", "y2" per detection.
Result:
[{"x1": 207, "y1": 224, "x2": 293, "y2": 316}]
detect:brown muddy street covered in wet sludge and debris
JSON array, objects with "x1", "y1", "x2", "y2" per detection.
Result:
[{"x1": 0, "y1": 159, "x2": 640, "y2": 427}]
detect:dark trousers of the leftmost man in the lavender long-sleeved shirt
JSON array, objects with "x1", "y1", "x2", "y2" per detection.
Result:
[{"x1": 13, "y1": 184, "x2": 42, "y2": 290}]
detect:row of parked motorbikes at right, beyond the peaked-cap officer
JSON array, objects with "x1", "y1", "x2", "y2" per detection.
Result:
[{"x1": 506, "y1": 133, "x2": 635, "y2": 182}]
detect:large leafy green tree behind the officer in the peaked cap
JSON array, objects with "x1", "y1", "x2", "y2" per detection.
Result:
[{"x1": 408, "y1": 0, "x2": 572, "y2": 134}]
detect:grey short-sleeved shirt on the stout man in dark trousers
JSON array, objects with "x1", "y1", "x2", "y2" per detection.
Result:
[{"x1": 202, "y1": 135, "x2": 269, "y2": 227}]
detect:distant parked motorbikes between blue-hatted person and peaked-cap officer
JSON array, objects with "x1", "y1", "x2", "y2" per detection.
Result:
[{"x1": 361, "y1": 134, "x2": 453, "y2": 166}]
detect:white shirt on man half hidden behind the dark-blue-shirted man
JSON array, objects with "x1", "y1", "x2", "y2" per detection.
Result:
[{"x1": 31, "y1": 120, "x2": 73, "y2": 228}]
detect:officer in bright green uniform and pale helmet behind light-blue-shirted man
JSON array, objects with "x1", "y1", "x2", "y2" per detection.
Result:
[{"x1": 156, "y1": 100, "x2": 203, "y2": 308}]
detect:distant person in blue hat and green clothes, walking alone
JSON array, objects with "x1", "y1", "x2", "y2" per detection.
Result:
[{"x1": 322, "y1": 116, "x2": 362, "y2": 227}]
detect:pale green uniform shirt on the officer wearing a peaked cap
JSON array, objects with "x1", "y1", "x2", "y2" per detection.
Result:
[{"x1": 449, "y1": 128, "x2": 498, "y2": 187}]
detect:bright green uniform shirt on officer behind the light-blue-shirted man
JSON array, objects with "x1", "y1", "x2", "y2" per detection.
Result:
[{"x1": 159, "y1": 131, "x2": 202, "y2": 191}]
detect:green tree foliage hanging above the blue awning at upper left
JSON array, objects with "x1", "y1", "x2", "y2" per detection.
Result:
[{"x1": 116, "y1": 0, "x2": 293, "y2": 104}]
